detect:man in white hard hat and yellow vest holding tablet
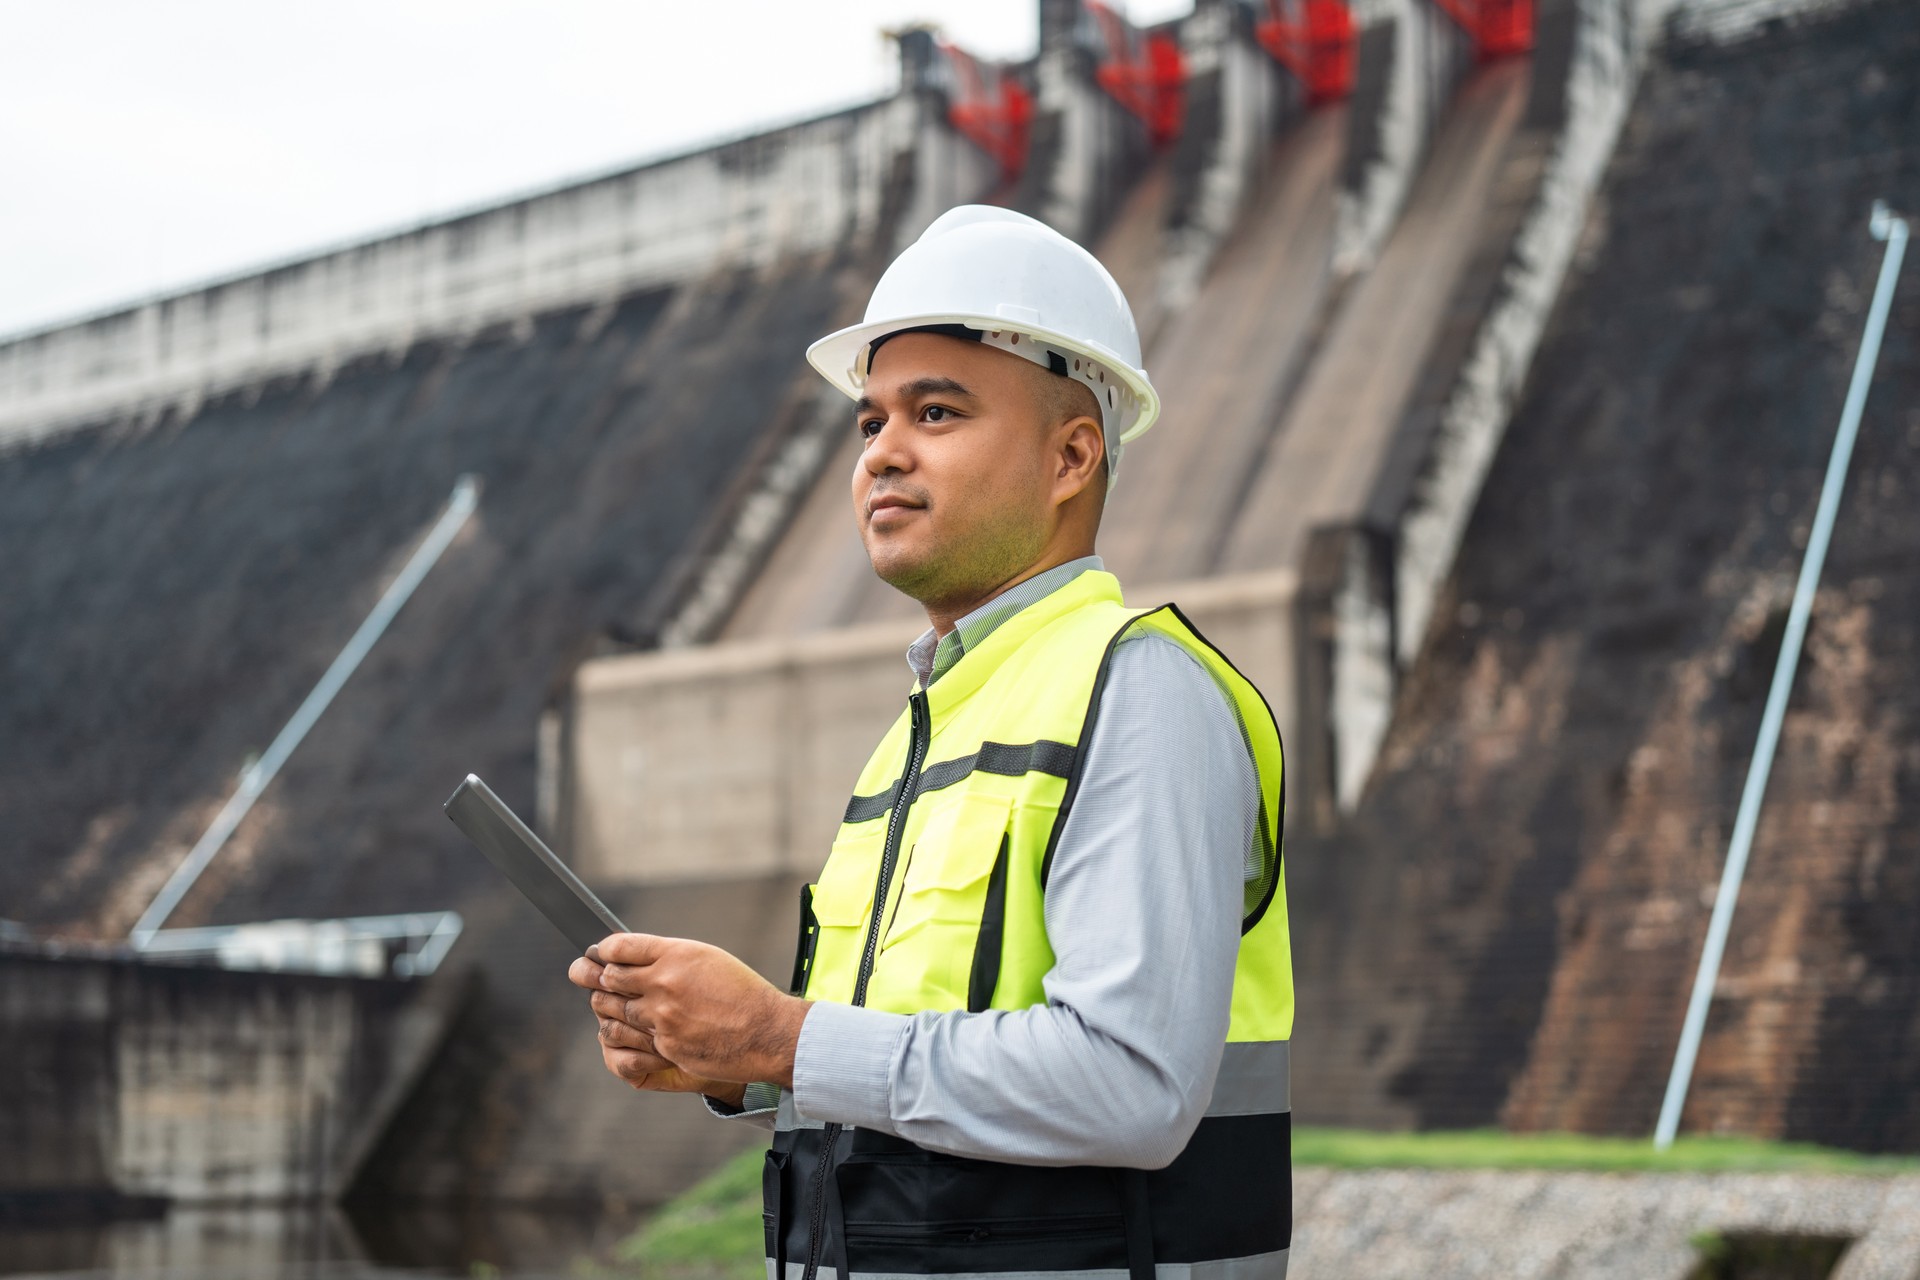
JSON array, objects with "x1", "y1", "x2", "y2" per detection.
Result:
[{"x1": 570, "y1": 207, "x2": 1292, "y2": 1280}]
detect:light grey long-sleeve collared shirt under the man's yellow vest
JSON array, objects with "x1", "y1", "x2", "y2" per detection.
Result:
[{"x1": 722, "y1": 557, "x2": 1261, "y2": 1169}]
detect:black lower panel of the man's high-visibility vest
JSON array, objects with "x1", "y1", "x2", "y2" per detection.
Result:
[{"x1": 766, "y1": 1115, "x2": 1292, "y2": 1274}]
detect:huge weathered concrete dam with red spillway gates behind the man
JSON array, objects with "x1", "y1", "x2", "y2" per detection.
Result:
[{"x1": 0, "y1": 0, "x2": 1920, "y2": 1270}]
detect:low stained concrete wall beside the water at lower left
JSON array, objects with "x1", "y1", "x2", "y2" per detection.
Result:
[{"x1": 0, "y1": 944, "x2": 463, "y2": 1213}]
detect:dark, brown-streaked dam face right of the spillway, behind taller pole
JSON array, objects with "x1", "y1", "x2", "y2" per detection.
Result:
[{"x1": 1290, "y1": 2, "x2": 1920, "y2": 1150}]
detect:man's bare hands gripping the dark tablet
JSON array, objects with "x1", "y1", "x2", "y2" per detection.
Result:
[{"x1": 566, "y1": 933, "x2": 810, "y2": 1105}]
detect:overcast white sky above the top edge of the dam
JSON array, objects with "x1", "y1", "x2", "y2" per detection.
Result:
[{"x1": 0, "y1": 0, "x2": 1192, "y2": 336}]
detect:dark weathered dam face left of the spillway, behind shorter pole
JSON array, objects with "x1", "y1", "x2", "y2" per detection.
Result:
[{"x1": 0, "y1": 261, "x2": 860, "y2": 936}]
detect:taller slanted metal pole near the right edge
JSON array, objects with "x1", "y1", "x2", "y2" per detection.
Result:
[{"x1": 1653, "y1": 208, "x2": 1907, "y2": 1151}]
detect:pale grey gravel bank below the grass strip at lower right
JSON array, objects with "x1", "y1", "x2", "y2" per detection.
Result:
[{"x1": 1290, "y1": 1169, "x2": 1920, "y2": 1280}]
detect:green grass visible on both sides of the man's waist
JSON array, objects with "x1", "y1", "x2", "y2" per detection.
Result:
[{"x1": 602, "y1": 1128, "x2": 1920, "y2": 1280}]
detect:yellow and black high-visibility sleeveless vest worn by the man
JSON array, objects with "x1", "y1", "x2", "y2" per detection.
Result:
[{"x1": 766, "y1": 572, "x2": 1294, "y2": 1280}]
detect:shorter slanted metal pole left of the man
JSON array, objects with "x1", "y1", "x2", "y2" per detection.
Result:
[{"x1": 131, "y1": 476, "x2": 480, "y2": 950}]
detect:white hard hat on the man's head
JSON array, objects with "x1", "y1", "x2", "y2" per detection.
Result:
[{"x1": 806, "y1": 205, "x2": 1160, "y2": 459}]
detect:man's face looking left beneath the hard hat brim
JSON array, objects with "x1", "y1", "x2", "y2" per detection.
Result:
[{"x1": 852, "y1": 334, "x2": 1058, "y2": 603}]
